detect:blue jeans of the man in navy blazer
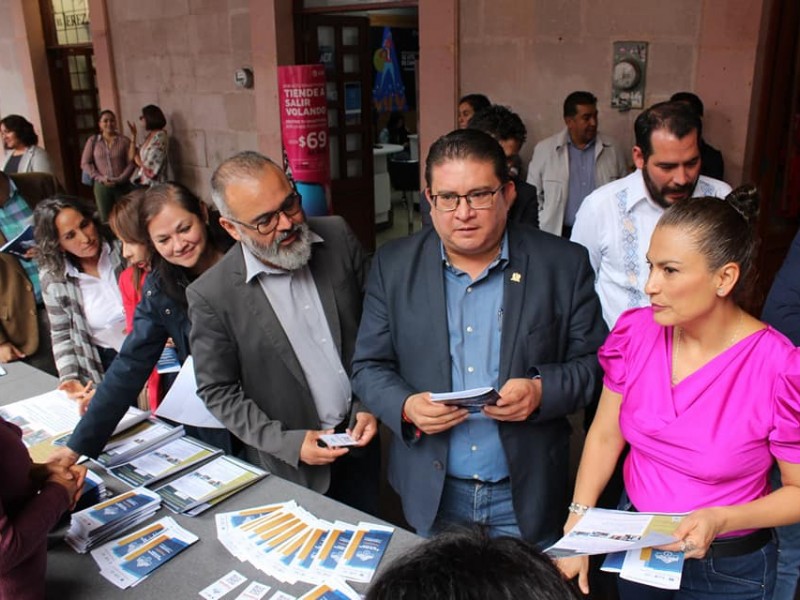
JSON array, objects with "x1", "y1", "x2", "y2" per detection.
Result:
[{"x1": 417, "y1": 477, "x2": 522, "y2": 537}]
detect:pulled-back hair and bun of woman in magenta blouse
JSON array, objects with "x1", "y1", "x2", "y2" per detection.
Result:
[{"x1": 656, "y1": 184, "x2": 761, "y2": 302}]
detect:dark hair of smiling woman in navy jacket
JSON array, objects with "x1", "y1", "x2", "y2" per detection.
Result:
[{"x1": 139, "y1": 181, "x2": 233, "y2": 308}]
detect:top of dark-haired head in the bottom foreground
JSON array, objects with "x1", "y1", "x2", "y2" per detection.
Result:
[{"x1": 367, "y1": 530, "x2": 580, "y2": 600}]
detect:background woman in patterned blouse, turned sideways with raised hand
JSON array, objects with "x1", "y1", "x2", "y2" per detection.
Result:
[{"x1": 128, "y1": 104, "x2": 169, "y2": 187}]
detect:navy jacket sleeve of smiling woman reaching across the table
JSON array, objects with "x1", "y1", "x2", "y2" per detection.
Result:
[{"x1": 67, "y1": 272, "x2": 189, "y2": 457}]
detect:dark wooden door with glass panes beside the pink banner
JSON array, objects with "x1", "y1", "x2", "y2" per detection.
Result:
[{"x1": 295, "y1": 15, "x2": 375, "y2": 252}]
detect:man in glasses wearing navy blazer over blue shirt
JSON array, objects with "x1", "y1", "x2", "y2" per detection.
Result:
[{"x1": 353, "y1": 129, "x2": 607, "y2": 544}]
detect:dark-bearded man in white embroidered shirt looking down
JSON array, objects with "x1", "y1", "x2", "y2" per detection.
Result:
[{"x1": 570, "y1": 102, "x2": 731, "y2": 329}]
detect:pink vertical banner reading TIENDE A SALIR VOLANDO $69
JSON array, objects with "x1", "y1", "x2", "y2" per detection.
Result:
[{"x1": 278, "y1": 65, "x2": 331, "y2": 215}]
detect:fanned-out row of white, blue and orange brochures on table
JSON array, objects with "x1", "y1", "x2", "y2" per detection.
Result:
[{"x1": 215, "y1": 501, "x2": 394, "y2": 584}]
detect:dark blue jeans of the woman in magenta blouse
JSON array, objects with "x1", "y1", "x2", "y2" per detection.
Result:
[{"x1": 617, "y1": 540, "x2": 778, "y2": 600}]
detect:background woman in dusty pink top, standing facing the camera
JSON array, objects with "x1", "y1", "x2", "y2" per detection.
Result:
[{"x1": 81, "y1": 110, "x2": 134, "y2": 223}]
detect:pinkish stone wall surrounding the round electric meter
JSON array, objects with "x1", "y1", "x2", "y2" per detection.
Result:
[{"x1": 459, "y1": 0, "x2": 763, "y2": 184}]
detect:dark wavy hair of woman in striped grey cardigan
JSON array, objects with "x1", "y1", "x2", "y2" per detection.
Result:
[{"x1": 33, "y1": 195, "x2": 113, "y2": 278}]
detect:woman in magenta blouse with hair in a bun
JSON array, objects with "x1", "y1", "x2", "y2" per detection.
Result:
[{"x1": 559, "y1": 187, "x2": 800, "y2": 600}]
